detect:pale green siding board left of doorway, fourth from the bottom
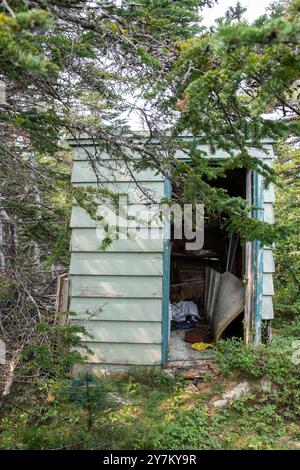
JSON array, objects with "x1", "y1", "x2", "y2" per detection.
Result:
[{"x1": 71, "y1": 275, "x2": 162, "y2": 299}]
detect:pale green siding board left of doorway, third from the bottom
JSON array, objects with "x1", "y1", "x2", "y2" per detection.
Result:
[{"x1": 70, "y1": 297, "x2": 162, "y2": 321}]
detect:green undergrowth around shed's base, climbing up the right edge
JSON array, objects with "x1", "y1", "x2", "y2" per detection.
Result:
[{"x1": 0, "y1": 141, "x2": 300, "y2": 450}]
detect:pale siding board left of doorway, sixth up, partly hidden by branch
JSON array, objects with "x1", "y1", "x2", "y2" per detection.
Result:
[{"x1": 71, "y1": 228, "x2": 163, "y2": 253}]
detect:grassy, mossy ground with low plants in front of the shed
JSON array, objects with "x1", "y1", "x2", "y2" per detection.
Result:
[{"x1": 0, "y1": 320, "x2": 300, "y2": 450}]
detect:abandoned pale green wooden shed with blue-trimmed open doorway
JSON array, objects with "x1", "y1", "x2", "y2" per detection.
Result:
[{"x1": 69, "y1": 139, "x2": 274, "y2": 373}]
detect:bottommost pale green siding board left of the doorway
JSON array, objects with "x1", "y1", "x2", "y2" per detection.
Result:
[{"x1": 79, "y1": 343, "x2": 161, "y2": 365}]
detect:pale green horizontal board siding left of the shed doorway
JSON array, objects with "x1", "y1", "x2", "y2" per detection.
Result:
[{"x1": 70, "y1": 147, "x2": 164, "y2": 373}]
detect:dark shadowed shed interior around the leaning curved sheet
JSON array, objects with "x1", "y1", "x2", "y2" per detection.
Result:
[{"x1": 170, "y1": 169, "x2": 246, "y2": 356}]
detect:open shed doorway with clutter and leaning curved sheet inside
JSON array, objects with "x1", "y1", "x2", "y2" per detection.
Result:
[{"x1": 169, "y1": 169, "x2": 246, "y2": 362}]
